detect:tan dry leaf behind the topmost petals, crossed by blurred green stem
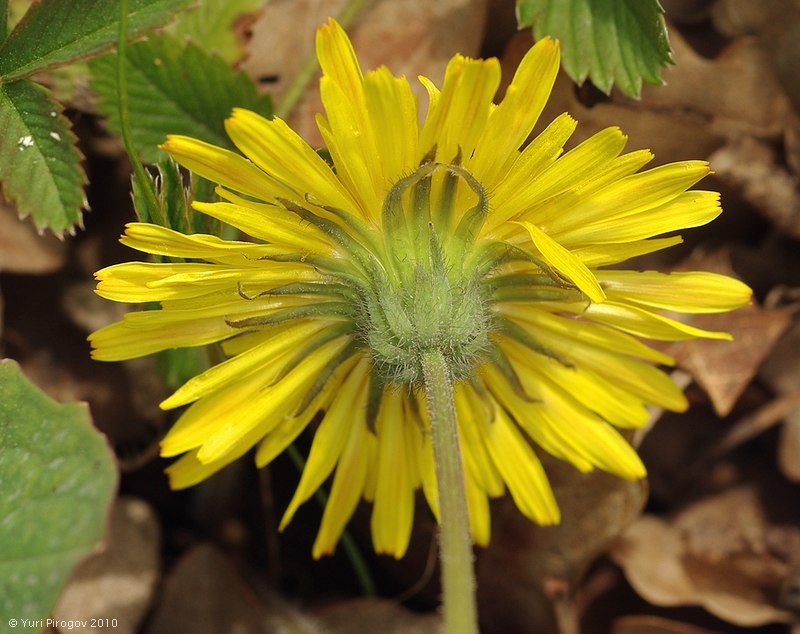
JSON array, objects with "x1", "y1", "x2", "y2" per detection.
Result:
[{"x1": 242, "y1": 0, "x2": 487, "y2": 146}]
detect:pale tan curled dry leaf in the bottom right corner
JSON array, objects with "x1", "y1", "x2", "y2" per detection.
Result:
[{"x1": 611, "y1": 486, "x2": 800, "y2": 627}]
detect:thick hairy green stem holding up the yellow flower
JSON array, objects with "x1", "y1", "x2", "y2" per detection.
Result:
[{"x1": 422, "y1": 350, "x2": 478, "y2": 634}]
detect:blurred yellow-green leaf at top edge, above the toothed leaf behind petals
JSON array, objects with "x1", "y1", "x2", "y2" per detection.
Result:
[{"x1": 167, "y1": 0, "x2": 264, "y2": 64}]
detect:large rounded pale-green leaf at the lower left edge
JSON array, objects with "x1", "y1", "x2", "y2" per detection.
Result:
[{"x1": 0, "y1": 360, "x2": 117, "y2": 620}]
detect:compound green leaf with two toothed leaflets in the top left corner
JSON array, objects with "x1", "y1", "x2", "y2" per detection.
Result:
[{"x1": 0, "y1": 0, "x2": 192, "y2": 234}]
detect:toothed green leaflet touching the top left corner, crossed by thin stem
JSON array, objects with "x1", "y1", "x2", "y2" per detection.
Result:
[{"x1": 0, "y1": 0, "x2": 193, "y2": 81}]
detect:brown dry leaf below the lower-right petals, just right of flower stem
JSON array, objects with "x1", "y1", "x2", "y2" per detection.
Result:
[{"x1": 477, "y1": 460, "x2": 646, "y2": 634}]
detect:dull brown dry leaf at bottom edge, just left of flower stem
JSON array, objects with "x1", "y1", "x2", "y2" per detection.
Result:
[{"x1": 316, "y1": 598, "x2": 442, "y2": 634}]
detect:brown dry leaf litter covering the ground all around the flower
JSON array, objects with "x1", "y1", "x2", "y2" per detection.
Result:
[{"x1": 0, "y1": 0, "x2": 800, "y2": 634}]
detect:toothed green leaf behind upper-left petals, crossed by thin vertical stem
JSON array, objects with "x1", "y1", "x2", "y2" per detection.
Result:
[{"x1": 89, "y1": 35, "x2": 272, "y2": 163}]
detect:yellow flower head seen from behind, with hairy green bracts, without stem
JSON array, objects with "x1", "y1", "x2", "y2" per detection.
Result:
[{"x1": 90, "y1": 21, "x2": 750, "y2": 557}]
